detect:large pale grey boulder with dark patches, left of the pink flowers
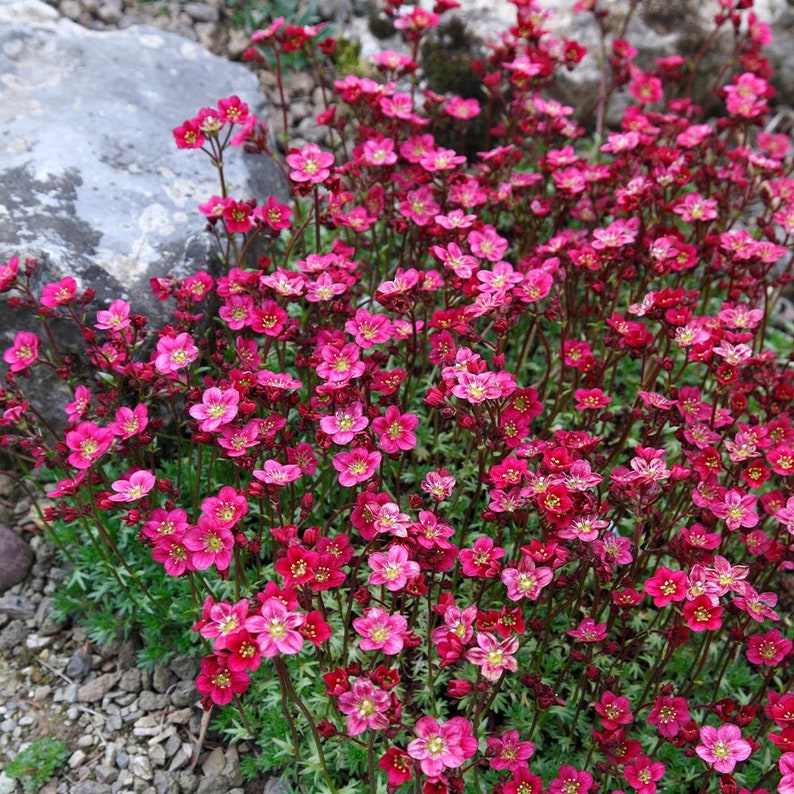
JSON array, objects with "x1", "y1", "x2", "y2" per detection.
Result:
[{"x1": 0, "y1": 0, "x2": 283, "y2": 322}]
